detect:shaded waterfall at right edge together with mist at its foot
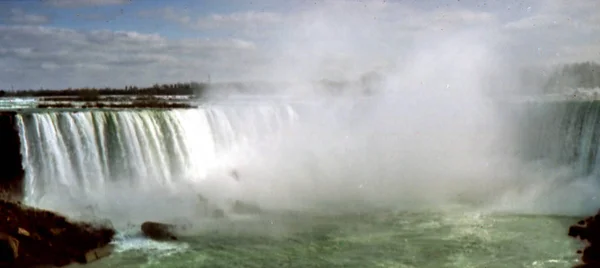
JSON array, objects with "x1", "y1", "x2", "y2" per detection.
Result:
[{"x1": 486, "y1": 100, "x2": 600, "y2": 215}]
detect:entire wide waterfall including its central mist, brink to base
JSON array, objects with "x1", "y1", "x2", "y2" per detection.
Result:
[{"x1": 12, "y1": 95, "x2": 600, "y2": 222}]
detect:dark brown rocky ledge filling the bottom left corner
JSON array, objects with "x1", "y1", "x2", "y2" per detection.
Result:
[{"x1": 0, "y1": 200, "x2": 115, "y2": 267}]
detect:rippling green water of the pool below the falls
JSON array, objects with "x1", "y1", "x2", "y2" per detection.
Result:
[{"x1": 82, "y1": 210, "x2": 578, "y2": 268}]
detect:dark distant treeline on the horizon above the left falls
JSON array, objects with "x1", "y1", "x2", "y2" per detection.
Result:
[{"x1": 0, "y1": 82, "x2": 208, "y2": 101}]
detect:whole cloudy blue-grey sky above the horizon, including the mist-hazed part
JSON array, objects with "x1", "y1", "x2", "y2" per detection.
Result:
[{"x1": 0, "y1": 0, "x2": 600, "y2": 90}]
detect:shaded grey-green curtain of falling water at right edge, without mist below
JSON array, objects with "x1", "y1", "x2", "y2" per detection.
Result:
[{"x1": 515, "y1": 101, "x2": 600, "y2": 177}]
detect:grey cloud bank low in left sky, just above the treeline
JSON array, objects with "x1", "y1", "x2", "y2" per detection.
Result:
[{"x1": 0, "y1": 25, "x2": 256, "y2": 88}]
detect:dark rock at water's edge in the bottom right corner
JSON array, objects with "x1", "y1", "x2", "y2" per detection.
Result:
[{"x1": 569, "y1": 212, "x2": 600, "y2": 268}]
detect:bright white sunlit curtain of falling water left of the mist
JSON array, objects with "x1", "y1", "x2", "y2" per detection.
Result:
[{"x1": 17, "y1": 105, "x2": 296, "y2": 222}]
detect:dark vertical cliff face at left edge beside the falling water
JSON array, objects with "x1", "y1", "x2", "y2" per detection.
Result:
[{"x1": 0, "y1": 112, "x2": 25, "y2": 201}]
